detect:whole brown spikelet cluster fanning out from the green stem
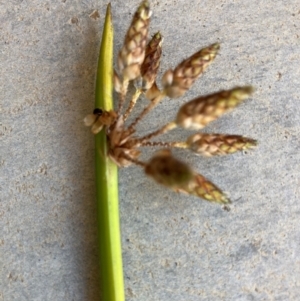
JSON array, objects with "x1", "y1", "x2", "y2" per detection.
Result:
[{"x1": 84, "y1": 1, "x2": 256, "y2": 204}]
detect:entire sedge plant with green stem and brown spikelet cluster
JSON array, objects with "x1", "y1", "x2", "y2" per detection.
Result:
[{"x1": 84, "y1": 1, "x2": 256, "y2": 301}]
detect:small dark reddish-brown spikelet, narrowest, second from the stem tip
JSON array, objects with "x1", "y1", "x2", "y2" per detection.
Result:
[{"x1": 141, "y1": 32, "x2": 163, "y2": 91}]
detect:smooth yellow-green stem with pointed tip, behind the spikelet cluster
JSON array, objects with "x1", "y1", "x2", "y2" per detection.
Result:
[{"x1": 95, "y1": 4, "x2": 125, "y2": 301}]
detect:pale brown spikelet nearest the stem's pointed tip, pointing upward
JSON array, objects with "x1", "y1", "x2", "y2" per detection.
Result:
[{"x1": 118, "y1": 1, "x2": 151, "y2": 80}]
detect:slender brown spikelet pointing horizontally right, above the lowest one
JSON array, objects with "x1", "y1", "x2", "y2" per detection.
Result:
[{"x1": 186, "y1": 133, "x2": 257, "y2": 156}]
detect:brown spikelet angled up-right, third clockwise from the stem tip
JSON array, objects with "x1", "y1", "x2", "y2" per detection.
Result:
[{"x1": 162, "y1": 43, "x2": 220, "y2": 98}]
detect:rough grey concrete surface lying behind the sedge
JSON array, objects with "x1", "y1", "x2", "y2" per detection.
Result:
[{"x1": 0, "y1": 0, "x2": 300, "y2": 301}]
